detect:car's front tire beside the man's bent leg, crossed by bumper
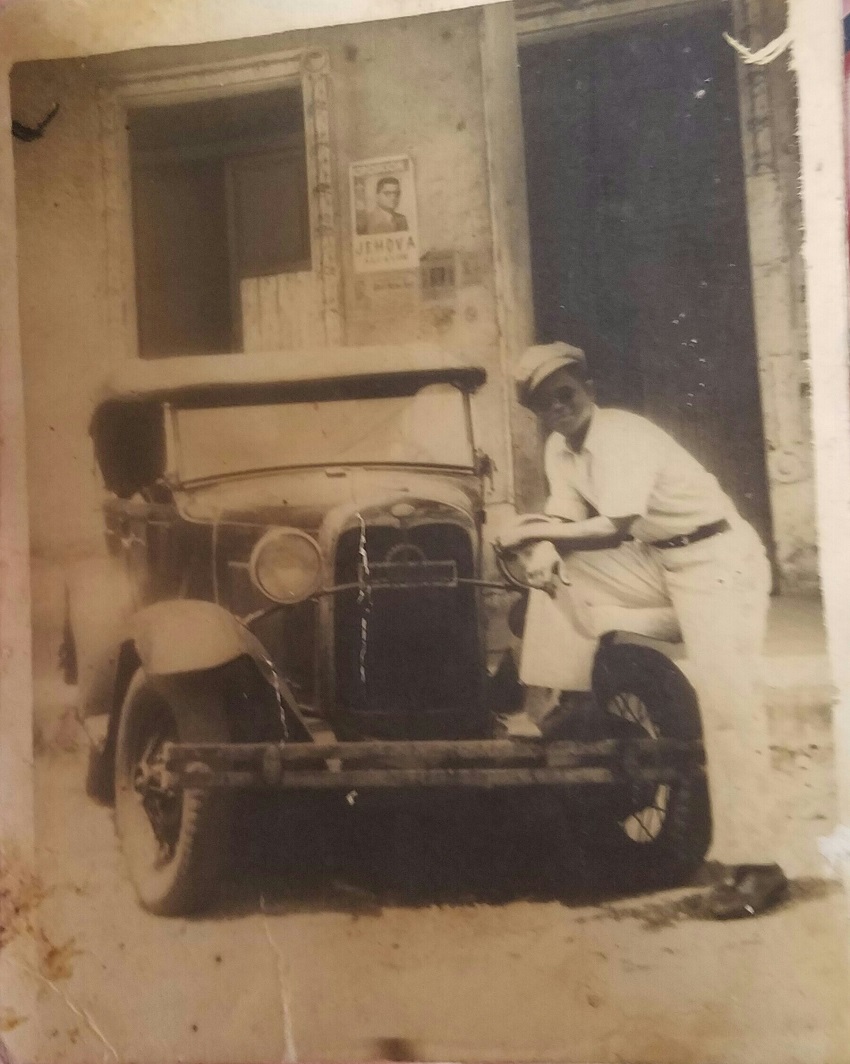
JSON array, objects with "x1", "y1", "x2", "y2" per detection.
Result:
[{"x1": 573, "y1": 643, "x2": 712, "y2": 890}]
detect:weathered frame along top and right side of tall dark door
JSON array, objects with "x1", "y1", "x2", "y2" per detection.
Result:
[{"x1": 508, "y1": 0, "x2": 817, "y2": 589}]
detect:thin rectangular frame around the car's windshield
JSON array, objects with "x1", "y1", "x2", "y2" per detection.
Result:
[{"x1": 163, "y1": 384, "x2": 478, "y2": 488}]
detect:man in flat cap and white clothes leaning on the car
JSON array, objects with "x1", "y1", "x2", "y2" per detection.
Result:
[{"x1": 500, "y1": 343, "x2": 787, "y2": 918}]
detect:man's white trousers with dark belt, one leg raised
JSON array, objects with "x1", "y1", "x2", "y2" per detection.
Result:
[{"x1": 520, "y1": 520, "x2": 778, "y2": 864}]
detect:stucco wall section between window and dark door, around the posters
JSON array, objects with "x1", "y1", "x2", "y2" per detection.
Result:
[{"x1": 336, "y1": 12, "x2": 498, "y2": 350}]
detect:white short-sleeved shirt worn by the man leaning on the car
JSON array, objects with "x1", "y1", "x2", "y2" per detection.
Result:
[{"x1": 544, "y1": 408, "x2": 735, "y2": 543}]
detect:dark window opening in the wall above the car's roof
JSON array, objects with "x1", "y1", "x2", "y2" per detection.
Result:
[{"x1": 128, "y1": 87, "x2": 312, "y2": 359}]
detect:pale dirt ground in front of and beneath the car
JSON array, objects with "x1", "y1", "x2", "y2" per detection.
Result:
[{"x1": 8, "y1": 715, "x2": 850, "y2": 1064}]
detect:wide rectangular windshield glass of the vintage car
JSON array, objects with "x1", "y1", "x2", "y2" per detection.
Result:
[{"x1": 173, "y1": 384, "x2": 473, "y2": 482}]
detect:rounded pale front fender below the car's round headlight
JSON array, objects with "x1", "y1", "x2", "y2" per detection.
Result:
[{"x1": 130, "y1": 599, "x2": 270, "y2": 676}]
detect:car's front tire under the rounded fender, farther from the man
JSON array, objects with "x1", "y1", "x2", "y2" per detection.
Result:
[{"x1": 115, "y1": 669, "x2": 232, "y2": 916}]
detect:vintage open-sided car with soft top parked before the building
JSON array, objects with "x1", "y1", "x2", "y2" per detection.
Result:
[{"x1": 63, "y1": 348, "x2": 711, "y2": 914}]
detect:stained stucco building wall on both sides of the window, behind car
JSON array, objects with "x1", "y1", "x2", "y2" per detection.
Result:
[{"x1": 12, "y1": 11, "x2": 509, "y2": 617}]
